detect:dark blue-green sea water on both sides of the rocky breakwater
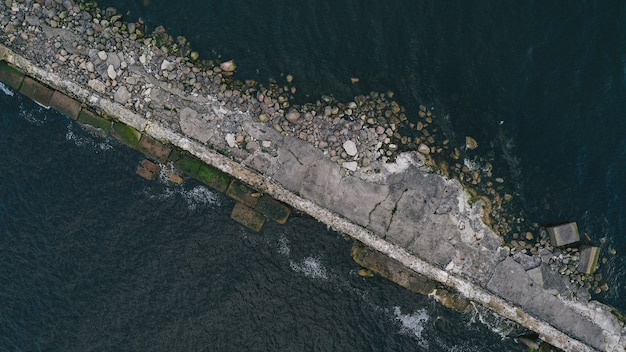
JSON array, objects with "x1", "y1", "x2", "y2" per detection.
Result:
[{"x1": 0, "y1": 0, "x2": 626, "y2": 351}]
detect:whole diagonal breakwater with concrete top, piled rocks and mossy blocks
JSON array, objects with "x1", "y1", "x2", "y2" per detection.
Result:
[{"x1": 0, "y1": 0, "x2": 626, "y2": 352}]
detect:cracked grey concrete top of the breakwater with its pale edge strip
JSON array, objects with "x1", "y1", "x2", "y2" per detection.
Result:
[{"x1": 0, "y1": 4, "x2": 626, "y2": 351}]
